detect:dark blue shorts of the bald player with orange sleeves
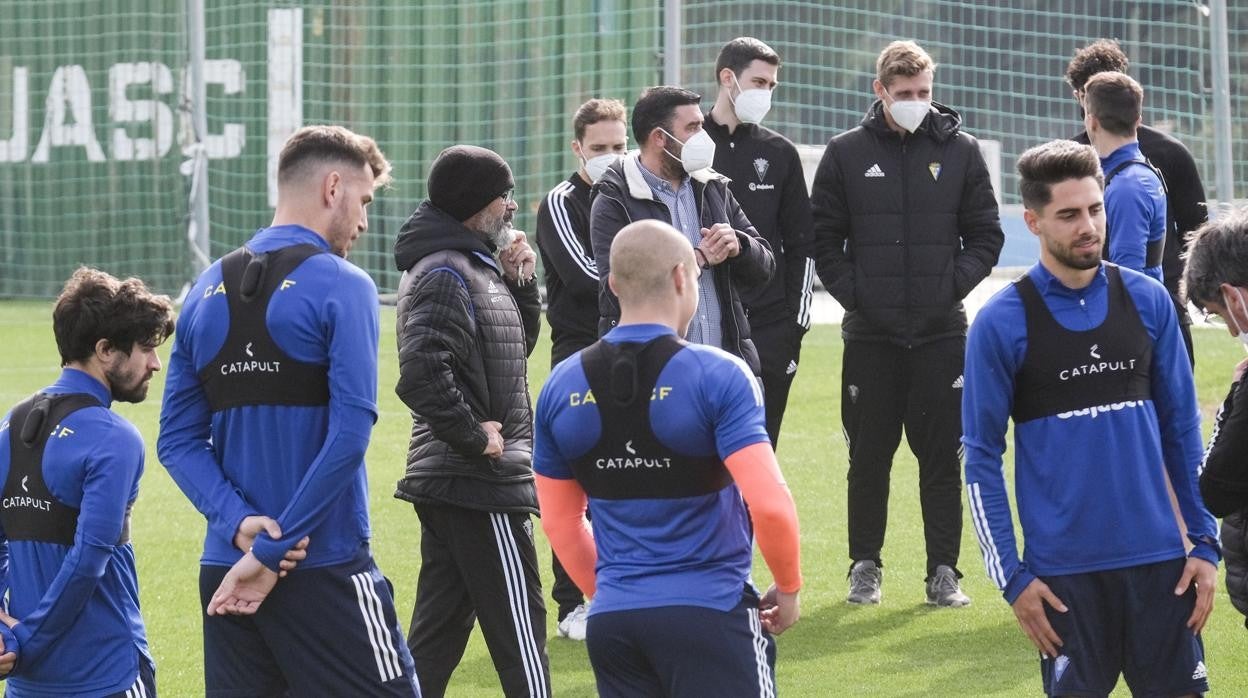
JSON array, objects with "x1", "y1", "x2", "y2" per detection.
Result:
[{"x1": 585, "y1": 594, "x2": 776, "y2": 698}]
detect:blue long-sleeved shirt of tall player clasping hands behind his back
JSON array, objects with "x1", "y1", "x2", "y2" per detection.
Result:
[{"x1": 157, "y1": 226, "x2": 378, "y2": 569}]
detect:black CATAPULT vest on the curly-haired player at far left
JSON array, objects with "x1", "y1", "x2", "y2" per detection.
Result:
[{"x1": 0, "y1": 393, "x2": 134, "y2": 546}]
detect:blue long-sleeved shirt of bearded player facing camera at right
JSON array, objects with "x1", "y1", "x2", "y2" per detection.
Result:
[{"x1": 962, "y1": 263, "x2": 1219, "y2": 603}]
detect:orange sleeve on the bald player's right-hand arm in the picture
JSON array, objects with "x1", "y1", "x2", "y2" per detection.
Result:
[{"x1": 723, "y1": 442, "x2": 801, "y2": 593}]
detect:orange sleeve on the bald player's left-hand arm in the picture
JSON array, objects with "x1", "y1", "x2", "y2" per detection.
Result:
[{"x1": 534, "y1": 473, "x2": 598, "y2": 598}]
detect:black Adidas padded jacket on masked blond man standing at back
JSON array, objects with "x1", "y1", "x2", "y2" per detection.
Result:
[{"x1": 810, "y1": 100, "x2": 1005, "y2": 346}]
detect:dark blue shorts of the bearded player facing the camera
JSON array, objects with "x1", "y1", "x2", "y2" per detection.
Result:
[{"x1": 1040, "y1": 558, "x2": 1209, "y2": 697}]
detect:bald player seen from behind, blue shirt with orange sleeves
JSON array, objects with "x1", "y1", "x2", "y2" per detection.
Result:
[{"x1": 533, "y1": 220, "x2": 801, "y2": 698}]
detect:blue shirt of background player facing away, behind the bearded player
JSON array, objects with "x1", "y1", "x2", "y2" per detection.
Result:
[{"x1": 1101, "y1": 142, "x2": 1166, "y2": 281}]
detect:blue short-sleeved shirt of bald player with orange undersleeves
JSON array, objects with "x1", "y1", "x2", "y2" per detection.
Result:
[{"x1": 533, "y1": 325, "x2": 769, "y2": 614}]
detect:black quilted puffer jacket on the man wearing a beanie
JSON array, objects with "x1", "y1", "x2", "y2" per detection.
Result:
[{"x1": 394, "y1": 201, "x2": 542, "y2": 513}]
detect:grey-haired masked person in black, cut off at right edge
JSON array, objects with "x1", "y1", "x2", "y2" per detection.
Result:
[{"x1": 1182, "y1": 209, "x2": 1248, "y2": 626}]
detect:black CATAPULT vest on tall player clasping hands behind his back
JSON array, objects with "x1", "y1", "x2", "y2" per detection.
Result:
[{"x1": 200, "y1": 245, "x2": 329, "y2": 412}]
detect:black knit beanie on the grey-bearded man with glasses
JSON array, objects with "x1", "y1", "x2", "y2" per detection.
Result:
[{"x1": 426, "y1": 145, "x2": 515, "y2": 222}]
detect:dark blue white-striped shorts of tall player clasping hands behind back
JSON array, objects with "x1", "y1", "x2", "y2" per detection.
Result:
[{"x1": 200, "y1": 548, "x2": 421, "y2": 698}]
